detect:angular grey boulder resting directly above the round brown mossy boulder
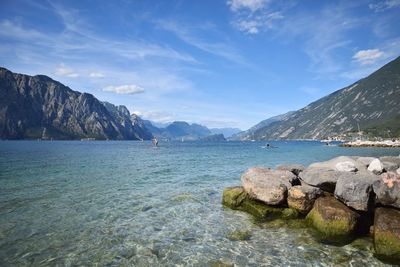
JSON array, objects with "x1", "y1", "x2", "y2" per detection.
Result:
[{"x1": 335, "y1": 172, "x2": 379, "y2": 211}]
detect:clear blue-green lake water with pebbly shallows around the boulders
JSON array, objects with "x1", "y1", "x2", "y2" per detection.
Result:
[{"x1": 0, "y1": 141, "x2": 400, "y2": 266}]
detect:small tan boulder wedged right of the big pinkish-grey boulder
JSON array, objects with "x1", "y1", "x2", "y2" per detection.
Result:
[{"x1": 288, "y1": 184, "x2": 323, "y2": 214}]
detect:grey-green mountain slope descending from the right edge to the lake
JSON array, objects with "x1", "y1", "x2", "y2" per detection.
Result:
[{"x1": 247, "y1": 57, "x2": 400, "y2": 140}]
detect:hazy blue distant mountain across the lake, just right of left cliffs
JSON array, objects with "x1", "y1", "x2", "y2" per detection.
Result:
[{"x1": 144, "y1": 121, "x2": 211, "y2": 140}]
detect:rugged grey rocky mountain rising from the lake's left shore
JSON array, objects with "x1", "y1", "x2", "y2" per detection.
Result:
[{"x1": 0, "y1": 68, "x2": 152, "y2": 140}]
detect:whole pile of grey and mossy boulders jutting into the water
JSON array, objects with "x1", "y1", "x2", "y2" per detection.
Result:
[{"x1": 222, "y1": 156, "x2": 400, "y2": 263}]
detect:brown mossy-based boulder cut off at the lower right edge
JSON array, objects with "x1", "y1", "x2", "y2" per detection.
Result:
[{"x1": 374, "y1": 208, "x2": 400, "y2": 263}]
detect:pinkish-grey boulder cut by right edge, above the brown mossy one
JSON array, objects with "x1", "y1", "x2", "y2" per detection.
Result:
[{"x1": 373, "y1": 172, "x2": 400, "y2": 208}]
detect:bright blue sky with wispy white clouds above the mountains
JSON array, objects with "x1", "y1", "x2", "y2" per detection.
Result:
[{"x1": 0, "y1": 0, "x2": 400, "y2": 129}]
